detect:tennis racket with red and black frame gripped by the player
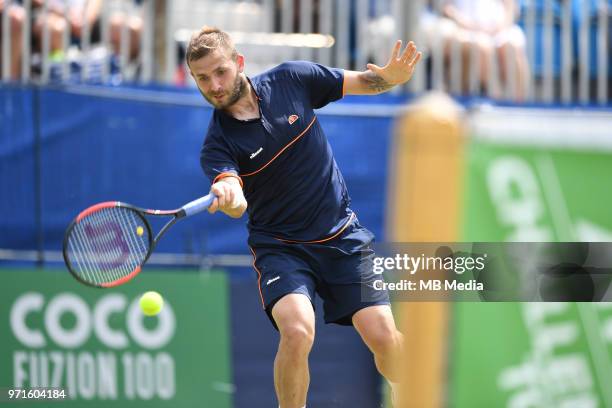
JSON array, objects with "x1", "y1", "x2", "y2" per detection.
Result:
[{"x1": 63, "y1": 194, "x2": 215, "y2": 288}]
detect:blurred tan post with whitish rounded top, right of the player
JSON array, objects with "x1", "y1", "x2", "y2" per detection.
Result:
[{"x1": 387, "y1": 94, "x2": 463, "y2": 408}]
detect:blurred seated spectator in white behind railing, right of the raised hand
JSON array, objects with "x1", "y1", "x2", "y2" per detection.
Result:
[{"x1": 424, "y1": 0, "x2": 529, "y2": 101}]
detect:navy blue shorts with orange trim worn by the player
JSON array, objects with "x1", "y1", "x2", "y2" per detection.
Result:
[{"x1": 249, "y1": 219, "x2": 389, "y2": 328}]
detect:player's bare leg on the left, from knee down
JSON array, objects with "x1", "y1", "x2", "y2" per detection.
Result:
[{"x1": 272, "y1": 294, "x2": 315, "y2": 408}]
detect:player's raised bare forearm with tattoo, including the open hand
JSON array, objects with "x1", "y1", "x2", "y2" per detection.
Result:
[{"x1": 344, "y1": 40, "x2": 421, "y2": 95}]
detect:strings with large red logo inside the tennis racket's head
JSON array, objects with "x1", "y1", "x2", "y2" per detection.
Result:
[{"x1": 67, "y1": 207, "x2": 151, "y2": 285}]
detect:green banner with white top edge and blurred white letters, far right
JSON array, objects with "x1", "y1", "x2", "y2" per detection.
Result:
[{"x1": 448, "y1": 109, "x2": 612, "y2": 408}]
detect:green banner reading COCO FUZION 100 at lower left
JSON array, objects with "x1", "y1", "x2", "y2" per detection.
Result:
[{"x1": 0, "y1": 270, "x2": 232, "y2": 408}]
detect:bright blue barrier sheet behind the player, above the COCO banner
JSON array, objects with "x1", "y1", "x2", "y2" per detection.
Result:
[{"x1": 0, "y1": 86, "x2": 402, "y2": 264}]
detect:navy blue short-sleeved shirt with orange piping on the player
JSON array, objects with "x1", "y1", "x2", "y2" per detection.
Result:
[{"x1": 200, "y1": 61, "x2": 352, "y2": 241}]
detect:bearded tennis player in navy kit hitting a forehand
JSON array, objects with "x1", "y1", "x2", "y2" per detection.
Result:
[{"x1": 186, "y1": 27, "x2": 421, "y2": 408}]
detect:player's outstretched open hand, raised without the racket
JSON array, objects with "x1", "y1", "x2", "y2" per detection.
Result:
[{"x1": 367, "y1": 40, "x2": 422, "y2": 85}]
